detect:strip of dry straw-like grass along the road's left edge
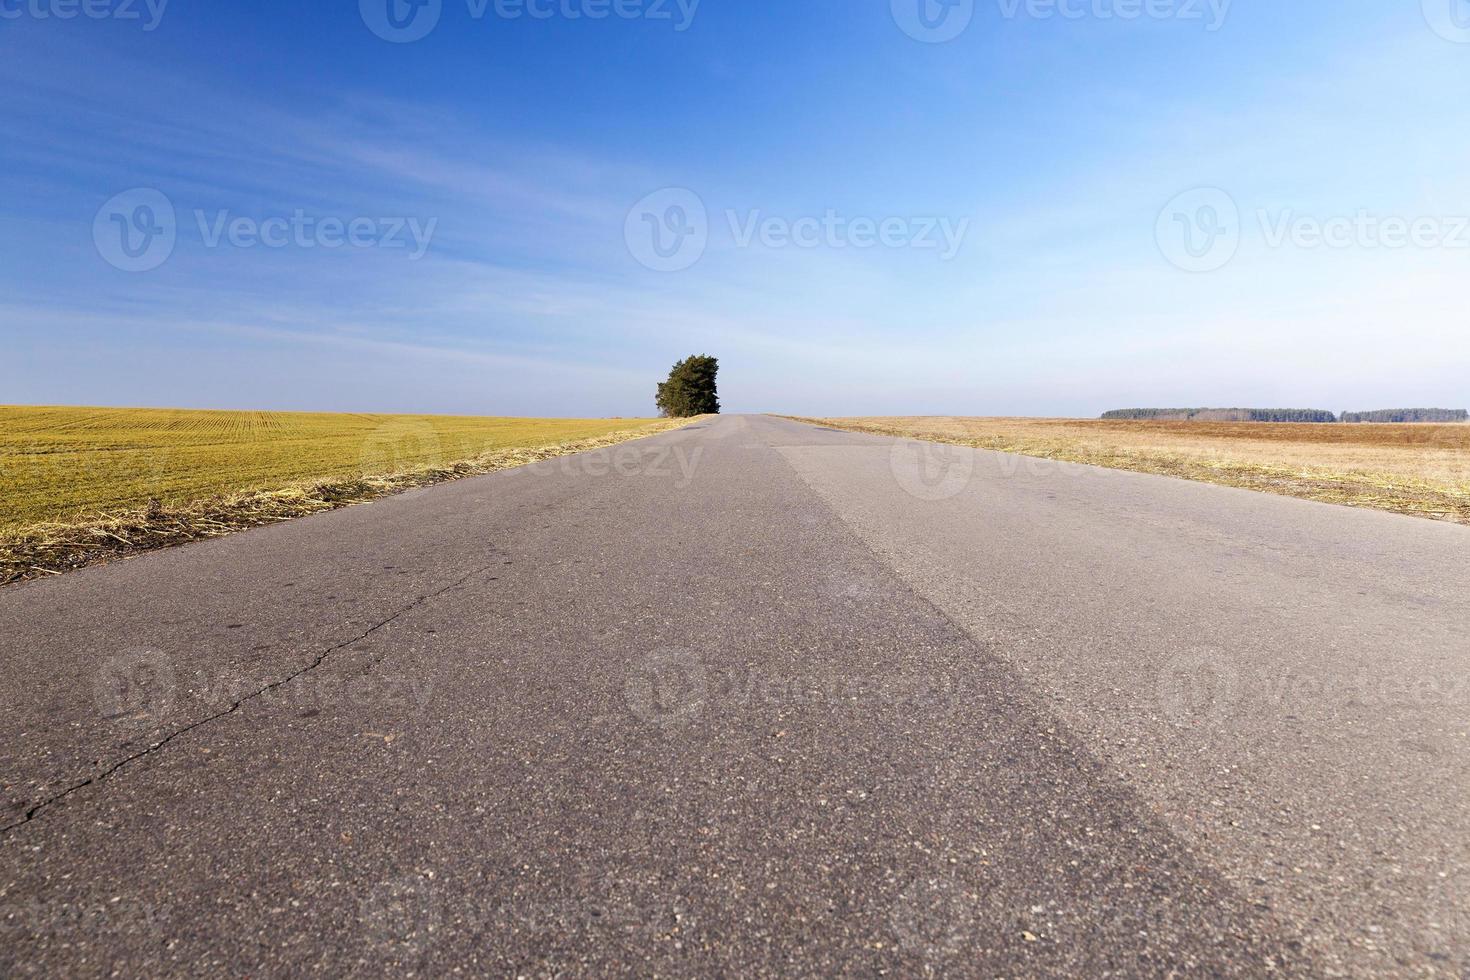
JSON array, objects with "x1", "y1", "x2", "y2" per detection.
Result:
[{"x1": 0, "y1": 416, "x2": 697, "y2": 585}]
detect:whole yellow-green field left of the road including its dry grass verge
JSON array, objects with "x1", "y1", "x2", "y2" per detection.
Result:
[{"x1": 0, "y1": 406, "x2": 691, "y2": 585}]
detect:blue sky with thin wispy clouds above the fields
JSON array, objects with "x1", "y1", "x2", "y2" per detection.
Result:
[{"x1": 0, "y1": 0, "x2": 1470, "y2": 416}]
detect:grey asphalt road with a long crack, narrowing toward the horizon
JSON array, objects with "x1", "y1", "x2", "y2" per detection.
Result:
[{"x1": 0, "y1": 417, "x2": 1470, "y2": 977}]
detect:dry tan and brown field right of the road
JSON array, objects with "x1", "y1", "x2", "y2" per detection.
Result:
[{"x1": 804, "y1": 416, "x2": 1470, "y2": 525}]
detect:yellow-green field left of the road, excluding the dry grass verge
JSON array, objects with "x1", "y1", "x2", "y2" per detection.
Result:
[{"x1": 0, "y1": 407, "x2": 659, "y2": 536}]
